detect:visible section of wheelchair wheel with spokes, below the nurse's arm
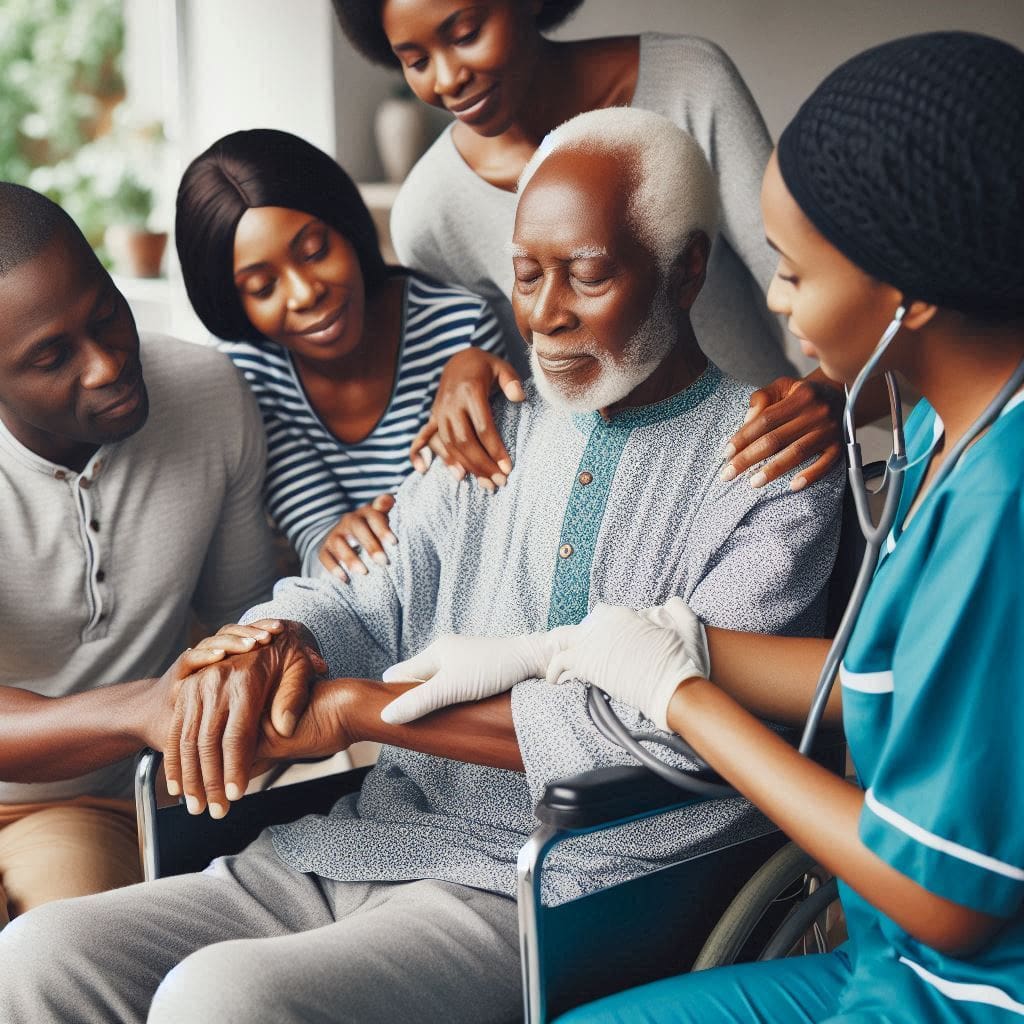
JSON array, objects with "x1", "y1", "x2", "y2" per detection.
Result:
[{"x1": 691, "y1": 843, "x2": 838, "y2": 971}]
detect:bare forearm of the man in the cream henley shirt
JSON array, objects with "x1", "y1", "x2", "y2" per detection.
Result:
[{"x1": 0, "y1": 679, "x2": 156, "y2": 782}]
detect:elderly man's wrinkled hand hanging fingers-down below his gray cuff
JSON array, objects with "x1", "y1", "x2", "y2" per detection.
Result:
[{"x1": 162, "y1": 622, "x2": 327, "y2": 817}]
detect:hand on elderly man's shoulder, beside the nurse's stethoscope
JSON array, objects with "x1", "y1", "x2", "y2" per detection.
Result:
[{"x1": 722, "y1": 371, "x2": 845, "y2": 490}]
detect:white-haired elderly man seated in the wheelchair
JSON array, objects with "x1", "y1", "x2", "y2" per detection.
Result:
[{"x1": 0, "y1": 111, "x2": 838, "y2": 1024}]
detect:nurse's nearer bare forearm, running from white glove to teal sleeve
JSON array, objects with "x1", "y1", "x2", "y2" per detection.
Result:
[{"x1": 668, "y1": 680, "x2": 1000, "y2": 953}]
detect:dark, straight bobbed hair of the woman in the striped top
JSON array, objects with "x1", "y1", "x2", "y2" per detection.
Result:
[{"x1": 174, "y1": 128, "x2": 388, "y2": 341}]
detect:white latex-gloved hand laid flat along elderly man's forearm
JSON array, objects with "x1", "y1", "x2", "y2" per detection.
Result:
[{"x1": 381, "y1": 626, "x2": 579, "y2": 725}]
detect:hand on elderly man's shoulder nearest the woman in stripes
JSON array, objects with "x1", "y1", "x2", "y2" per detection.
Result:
[{"x1": 409, "y1": 348, "x2": 525, "y2": 490}]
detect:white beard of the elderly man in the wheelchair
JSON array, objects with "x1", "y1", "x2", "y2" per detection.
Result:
[{"x1": 529, "y1": 291, "x2": 676, "y2": 413}]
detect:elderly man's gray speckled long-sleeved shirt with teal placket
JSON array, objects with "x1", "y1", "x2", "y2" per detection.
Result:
[{"x1": 246, "y1": 366, "x2": 842, "y2": 903}]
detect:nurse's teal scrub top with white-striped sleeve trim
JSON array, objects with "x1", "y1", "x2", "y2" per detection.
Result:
[{"x1": 840, "y1": 395, "x2": 1024, "y2": 1022}]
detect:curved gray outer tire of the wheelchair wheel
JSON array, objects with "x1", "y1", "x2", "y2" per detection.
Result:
[{"x1": 690, "y1": 843, "x2": 829, "y2": 971}]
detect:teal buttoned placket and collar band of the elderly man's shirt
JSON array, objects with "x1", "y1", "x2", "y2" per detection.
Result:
[{"x1": 548, "y1": 362, "x2": 722, "y2": 630}]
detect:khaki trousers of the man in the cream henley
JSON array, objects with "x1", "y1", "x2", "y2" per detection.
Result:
[{"x1": 0, "y1": 797, "x2": 142, "y2": 928}]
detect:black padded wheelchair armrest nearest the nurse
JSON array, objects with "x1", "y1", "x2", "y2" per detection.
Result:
[{"x1": 535, "y1": 765, "x2": 699, "y2": 830}]
